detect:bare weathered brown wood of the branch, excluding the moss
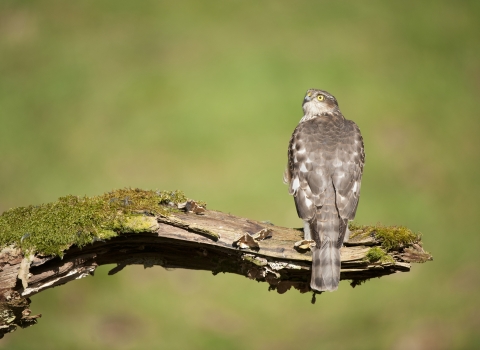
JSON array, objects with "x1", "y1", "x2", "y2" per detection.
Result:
[{"x1": 0, "y1": 206, "x2": 431, "y2": 337}]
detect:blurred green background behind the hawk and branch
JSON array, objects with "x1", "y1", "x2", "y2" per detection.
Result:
[{"x1": 0, "y1": 0, "x2": 480, "y2": 350}]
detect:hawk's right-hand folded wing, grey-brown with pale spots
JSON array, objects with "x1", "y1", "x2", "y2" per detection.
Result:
[{"x1": 333, "y1": 120, "x2": 365, "y2": 220}]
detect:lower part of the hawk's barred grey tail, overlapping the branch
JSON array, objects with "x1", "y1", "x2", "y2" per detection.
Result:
[{"x1": 310, "y1": 240, "x2": 340, "y2": 292}]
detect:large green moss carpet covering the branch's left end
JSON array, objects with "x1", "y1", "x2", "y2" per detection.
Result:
[{"x1": 0, "y1": 188, "x2": 191, "y2": 256}]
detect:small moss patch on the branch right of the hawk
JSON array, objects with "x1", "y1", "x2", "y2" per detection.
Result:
[{"x1": 349, "y1": 223, "x2": 421, "y2": 252}]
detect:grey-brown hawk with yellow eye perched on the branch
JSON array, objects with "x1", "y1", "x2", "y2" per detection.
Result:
[{"x1": 284, "y1": 89, "x2": 365, "y2": 293}]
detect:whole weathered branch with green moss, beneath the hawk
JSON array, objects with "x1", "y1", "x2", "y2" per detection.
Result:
[{"x1": 0, "y1": 189, "x2": 431, "y2": 336}]
